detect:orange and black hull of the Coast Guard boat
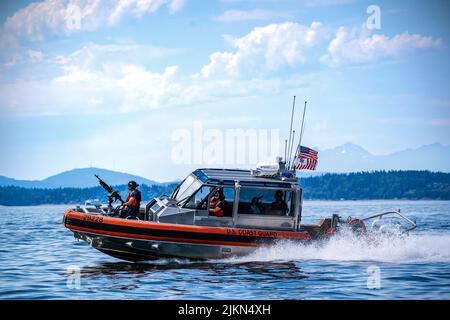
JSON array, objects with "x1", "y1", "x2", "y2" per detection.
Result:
[{"x1": 64, "y1": 210, "x2": 311, "y2": 261}]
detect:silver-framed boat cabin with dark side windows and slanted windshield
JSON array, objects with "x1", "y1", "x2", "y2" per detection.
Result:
[{"x1": 146, "y1": 169, "x2": 302, "y2": 231}]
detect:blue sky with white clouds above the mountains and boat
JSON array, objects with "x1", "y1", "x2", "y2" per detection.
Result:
[{"x1": 0, "y1": 0, "x2": 450, "y2": 181}]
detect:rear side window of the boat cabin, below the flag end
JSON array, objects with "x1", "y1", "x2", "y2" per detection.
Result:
[{"x1": 238, "y1": 187, "x2": 295, "y2": 217}]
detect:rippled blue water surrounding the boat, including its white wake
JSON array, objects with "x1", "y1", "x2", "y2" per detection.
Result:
[{"x1": 0, "y1": 201, "x2": 450, "y2": 299}]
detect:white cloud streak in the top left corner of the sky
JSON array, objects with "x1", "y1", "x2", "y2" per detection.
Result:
[{"x1": 2, "y1": 0, "x2": 185, "y2": 43}]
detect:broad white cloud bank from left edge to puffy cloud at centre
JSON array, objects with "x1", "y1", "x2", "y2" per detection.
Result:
[{"x1": 0, "y1": 22, "x2": 320, "y2": 115}]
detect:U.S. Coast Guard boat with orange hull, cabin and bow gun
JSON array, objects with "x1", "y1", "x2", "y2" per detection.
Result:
[{"x1": 63, "y1": 158, "x2": 415, "y2": 261}]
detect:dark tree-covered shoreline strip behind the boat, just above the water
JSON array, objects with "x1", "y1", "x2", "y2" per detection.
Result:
[{"x1": 0, "y1": 171, "x2": 450, "y2": 206}]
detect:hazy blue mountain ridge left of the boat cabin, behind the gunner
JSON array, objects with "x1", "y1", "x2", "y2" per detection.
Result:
[{"x1": 0, "y1": 168, "x2": 158, "y2": 188}]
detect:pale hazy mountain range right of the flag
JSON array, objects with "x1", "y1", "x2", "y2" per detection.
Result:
[{"x1": 317, "y1": 143, "x2": 450, "y2": 172}]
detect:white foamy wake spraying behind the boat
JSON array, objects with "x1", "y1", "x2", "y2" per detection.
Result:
[{"x1": 222, "y1": 234, "x2": 450, "y2": 263}]
